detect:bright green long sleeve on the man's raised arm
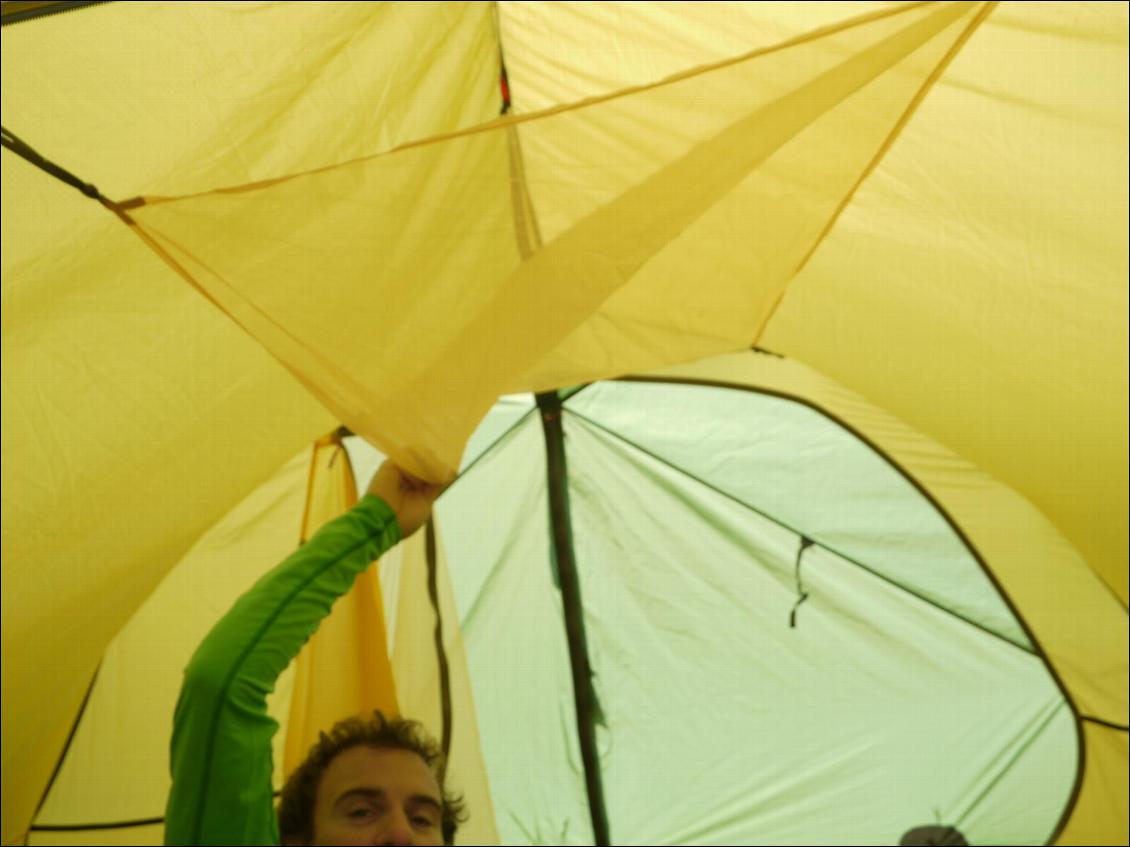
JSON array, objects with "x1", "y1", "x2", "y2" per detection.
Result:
[{"x1": 165, "y1": 496, "x2": 400, "y2": 845}]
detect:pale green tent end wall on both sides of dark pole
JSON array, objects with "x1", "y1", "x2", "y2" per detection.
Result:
[{"x1": 438, "y1": 384, "x2": 1077, "y2": 844}]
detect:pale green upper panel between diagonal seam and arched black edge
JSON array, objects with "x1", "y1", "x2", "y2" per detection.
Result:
[{"x1": 570, "y1": 384, "x2": 1031, "y2": 647}]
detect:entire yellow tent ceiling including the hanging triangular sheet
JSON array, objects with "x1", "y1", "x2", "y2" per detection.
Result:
[{"x1": 0, "y1": 2, "x2": 1128, "y2": 844}]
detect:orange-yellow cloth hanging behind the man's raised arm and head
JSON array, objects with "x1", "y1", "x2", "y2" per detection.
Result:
[{"x1": 277, "y1": 429, "x2": 498, "y2": 844}]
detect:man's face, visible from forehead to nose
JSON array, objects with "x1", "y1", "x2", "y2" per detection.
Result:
[{"x1": 314, "y1": 746, "x2": 443, "y2": 845}]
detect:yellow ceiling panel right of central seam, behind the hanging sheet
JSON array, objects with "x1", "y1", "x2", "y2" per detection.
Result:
[{"x1": 502, "y1": 2, "x2": 1130, "y2": 603}]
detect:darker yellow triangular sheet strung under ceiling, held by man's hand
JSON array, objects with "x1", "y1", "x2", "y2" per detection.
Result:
[{"x1": 123, "y1": 5, "x2": 986, "y2": 479}]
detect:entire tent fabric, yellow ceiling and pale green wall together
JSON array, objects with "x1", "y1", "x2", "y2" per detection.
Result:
[{"x1": 0, "y1": 2, "x2": 1130, "y2": 844}]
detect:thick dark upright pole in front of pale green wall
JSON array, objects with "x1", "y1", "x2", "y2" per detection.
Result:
[{"x1": 537, "y1": 391, "x2": 611, "y2": 847}]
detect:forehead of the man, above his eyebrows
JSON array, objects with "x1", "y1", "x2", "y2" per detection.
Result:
[{"x1": 319, "y1": 746, "x2": 440, "y2": 804}]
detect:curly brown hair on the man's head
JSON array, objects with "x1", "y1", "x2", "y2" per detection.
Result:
[{"x1": 278, "y1": 711, "x2": 467, "y2": 845}]
